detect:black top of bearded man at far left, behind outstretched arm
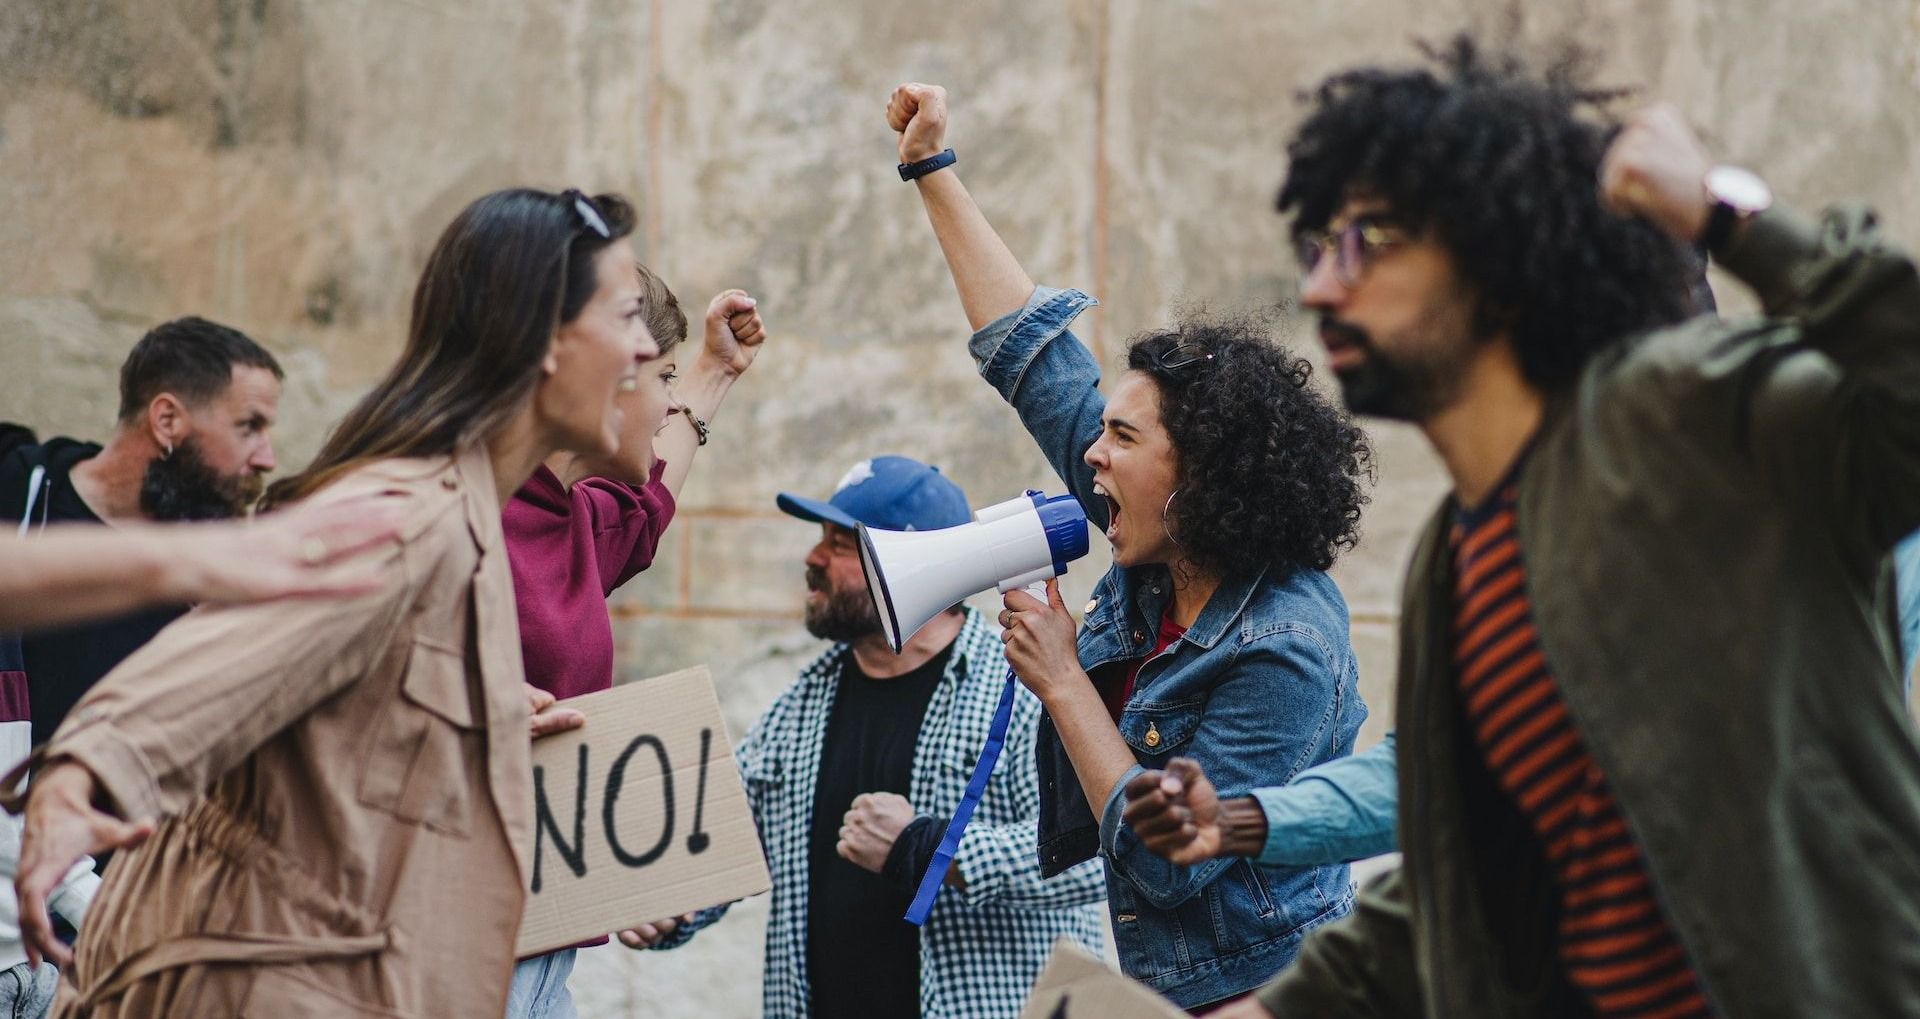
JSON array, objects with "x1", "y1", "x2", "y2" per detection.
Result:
[{"x1": 0, "y1": 439, "x2": 188, "y2": 745}]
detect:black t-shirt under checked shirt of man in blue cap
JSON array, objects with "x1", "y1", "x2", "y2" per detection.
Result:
[{"x1": 806, "y1": 645, "x2": 952, "y2": 1019}]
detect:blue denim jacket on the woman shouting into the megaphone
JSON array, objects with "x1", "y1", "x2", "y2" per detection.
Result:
[{"x1": 970, "y1": 288, "x2": 1367, "y2": 1007}]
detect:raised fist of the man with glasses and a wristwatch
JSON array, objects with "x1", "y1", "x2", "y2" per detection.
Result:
[{"x1": 1599, "y1": 104, "x2": 1713, "y2": 242}]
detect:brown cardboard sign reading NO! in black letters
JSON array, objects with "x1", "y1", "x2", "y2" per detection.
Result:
[{"x1": 515, "y1": 666, "x2": 772, "y2": 956}]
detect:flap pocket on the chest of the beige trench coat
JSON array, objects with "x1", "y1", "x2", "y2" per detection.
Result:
[{"x1": 359, "y1": 639, "x2": 486, "y2": 839}]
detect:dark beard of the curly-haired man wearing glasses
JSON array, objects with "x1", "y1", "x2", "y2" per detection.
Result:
[{"x1": 1321, "y1": 313, "x2": 1476, "y2": 424}]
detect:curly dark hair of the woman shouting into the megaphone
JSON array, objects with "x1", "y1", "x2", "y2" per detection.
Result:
[{"x1": 1127, "y1": 317, "x2": 1373, "y2": 576}]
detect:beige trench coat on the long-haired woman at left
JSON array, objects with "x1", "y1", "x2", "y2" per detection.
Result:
[{"x1": 11, "y1": 451, "x2": 532, "y2": 1019}]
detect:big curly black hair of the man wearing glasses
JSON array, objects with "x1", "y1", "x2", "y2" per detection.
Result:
[{"x1": 1279, "y1": 35, "x2": 1699, "y2": 391}]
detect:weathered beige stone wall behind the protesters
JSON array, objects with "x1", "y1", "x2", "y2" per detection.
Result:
[{"x1": 0, "y1": 0, "x2": 1920, "y2": 1017}]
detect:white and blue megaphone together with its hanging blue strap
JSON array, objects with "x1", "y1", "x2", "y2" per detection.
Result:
[{"x1": 858, "y1": 489, "x2": 1087, "y2": 927}]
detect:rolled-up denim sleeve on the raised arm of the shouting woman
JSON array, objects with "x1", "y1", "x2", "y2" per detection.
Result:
[{"x1": 968, "y1": 286, "x2": 1106, "y2": 530}]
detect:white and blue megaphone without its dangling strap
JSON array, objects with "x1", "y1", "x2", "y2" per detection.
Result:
[{"x1": 856, "y1": 489, "x2": 1087, "y2": 654}]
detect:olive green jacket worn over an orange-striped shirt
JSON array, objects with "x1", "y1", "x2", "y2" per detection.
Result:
[{"x1": 1260, "y1": 207, "x2": 1920, "y2": 1019}]
